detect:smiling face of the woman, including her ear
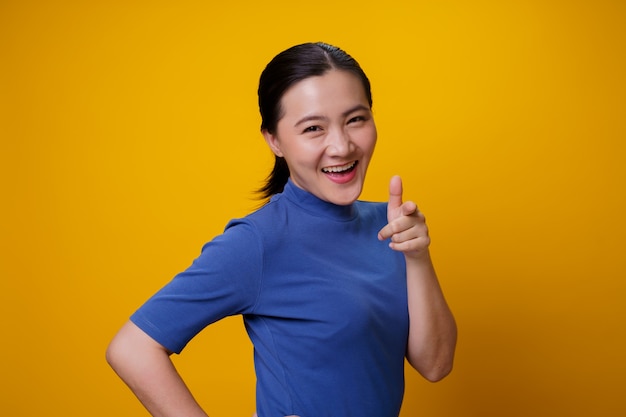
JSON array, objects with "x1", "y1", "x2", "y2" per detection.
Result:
[{"x1": 263, "y1": 70, "x2": 376, "y2": 205}]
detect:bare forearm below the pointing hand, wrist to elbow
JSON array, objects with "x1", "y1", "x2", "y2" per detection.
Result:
[{"x1": 406, "y1": 250, "x2": 457, "y2": 381}]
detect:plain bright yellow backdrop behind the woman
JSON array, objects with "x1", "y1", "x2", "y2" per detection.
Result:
[{"x1": 0, "y1": 0, "x2": 626, "y2": 417}]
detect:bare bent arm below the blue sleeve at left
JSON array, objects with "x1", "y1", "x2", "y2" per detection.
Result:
[{"x1": 107, "y1": 322, "x2": 207, "y2": 417}]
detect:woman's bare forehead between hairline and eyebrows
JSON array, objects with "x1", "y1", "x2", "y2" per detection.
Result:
[{"x1": 281, "y1": 70, "x2": 369, "y2": 117}]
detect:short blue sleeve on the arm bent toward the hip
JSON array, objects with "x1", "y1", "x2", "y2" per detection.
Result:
[{"x1": 131, "y1": 220, "x2": 263, "y2": 353}]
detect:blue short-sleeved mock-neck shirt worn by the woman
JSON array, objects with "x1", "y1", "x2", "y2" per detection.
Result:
[{"x1": 131, "y1": 181, "x2": 408, "y2": 417}]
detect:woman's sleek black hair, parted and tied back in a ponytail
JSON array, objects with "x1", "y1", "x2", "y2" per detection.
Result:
[{"x1": 258, "y1": 42, "x2": 372, "y2": 199}]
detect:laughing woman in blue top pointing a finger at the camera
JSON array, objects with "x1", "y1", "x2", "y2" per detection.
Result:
[{"x1": 107, "y1": 39, "x2": 456, "y2": 417}]
